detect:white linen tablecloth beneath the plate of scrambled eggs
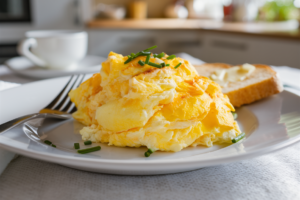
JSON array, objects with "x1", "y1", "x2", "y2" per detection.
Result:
[{"x1": 0, "y1": 57, "x2": 300, "y2": 200}]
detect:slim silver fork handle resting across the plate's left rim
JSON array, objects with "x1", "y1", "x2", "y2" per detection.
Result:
[{"x1": 0, "y1": 113, "x2": 71, "y2": 135}]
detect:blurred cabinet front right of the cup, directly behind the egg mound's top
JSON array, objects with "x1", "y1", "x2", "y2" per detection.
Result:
[{"x1": 88, "y1": 29, "x2": 203, "y2": 57}]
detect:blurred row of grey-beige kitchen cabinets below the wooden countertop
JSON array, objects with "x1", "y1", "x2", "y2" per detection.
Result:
[{"x1": 88, "y1": 29, "x2": 300, "y2": 68}]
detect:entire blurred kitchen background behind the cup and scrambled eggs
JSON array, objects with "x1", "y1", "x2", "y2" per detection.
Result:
[{"x1": 0, "y1": 0, "x2": 300, "y2": 68}]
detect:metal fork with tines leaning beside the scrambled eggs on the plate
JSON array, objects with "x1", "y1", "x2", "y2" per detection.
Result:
[{"x1": 0, "y1": 74, "x2": 85, "y2": 134}]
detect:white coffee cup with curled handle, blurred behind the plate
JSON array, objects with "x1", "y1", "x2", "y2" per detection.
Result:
[{"x1": 18, "y1": 30, "x2": 87, "y2": 69}]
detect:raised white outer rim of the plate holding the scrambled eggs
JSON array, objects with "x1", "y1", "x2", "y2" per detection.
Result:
[{"x1": 0, "y1": 76, "x2": 300, "y2": 170}]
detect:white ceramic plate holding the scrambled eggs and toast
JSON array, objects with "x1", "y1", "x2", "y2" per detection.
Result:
[{"x1": 0, "y1": 77, "x2": 300, "y2": 175}]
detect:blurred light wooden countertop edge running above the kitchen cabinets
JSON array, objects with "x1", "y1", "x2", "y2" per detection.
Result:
[{"x1": 87, "y1": 18, "x2": 300, "y2": 39}]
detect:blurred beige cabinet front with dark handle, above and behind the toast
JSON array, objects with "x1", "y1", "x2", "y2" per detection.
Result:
[{"x1": 203, "y1": 32, "x2": 300, "y2": 68}]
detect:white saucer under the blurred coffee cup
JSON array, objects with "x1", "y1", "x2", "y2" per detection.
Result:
[{"x1": 5, "y1": 55, "x2": 106, "y2": 79}]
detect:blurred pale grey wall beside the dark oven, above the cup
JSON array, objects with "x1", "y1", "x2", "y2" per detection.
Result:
[{"x1": 0, "y1": 0, "x2": 82, "y2": 43}]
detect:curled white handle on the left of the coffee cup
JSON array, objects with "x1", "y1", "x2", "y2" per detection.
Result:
[{"x1": 18, "y1": 38, "x2": 46, "y2": 67}]
